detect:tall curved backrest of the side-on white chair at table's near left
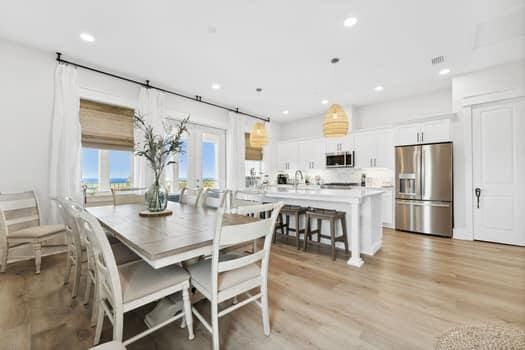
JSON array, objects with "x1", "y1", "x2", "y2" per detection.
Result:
[{"x1": 76, "y1": 211, "x2": 123, "y2": 329}]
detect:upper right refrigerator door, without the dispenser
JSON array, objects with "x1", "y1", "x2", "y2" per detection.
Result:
[{"x1": 421, "y1": 143, "x2": 452, "y2": 202}]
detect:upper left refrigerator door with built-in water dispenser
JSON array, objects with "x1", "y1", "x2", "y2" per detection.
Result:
[{"x1": 395, "y1": 146, "x2": 421, "y2": 199}]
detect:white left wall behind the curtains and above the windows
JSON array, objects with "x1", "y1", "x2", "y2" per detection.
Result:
[{"x1": 0, "y1": 38, "x2": 279, "y2": 221}]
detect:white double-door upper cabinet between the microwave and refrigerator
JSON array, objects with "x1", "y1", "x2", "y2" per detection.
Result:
[{"x1": 354, "y1": 130, "x2": 394, "y2": 169}]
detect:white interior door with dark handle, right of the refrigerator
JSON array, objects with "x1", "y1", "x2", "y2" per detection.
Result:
[{"x1": 472, "y1": 99, "x2": 525, "y2": 245}]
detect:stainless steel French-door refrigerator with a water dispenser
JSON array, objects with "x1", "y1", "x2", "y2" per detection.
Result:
[{"x1": 395, "y1": 142, "x2": 454, "y2": 237}]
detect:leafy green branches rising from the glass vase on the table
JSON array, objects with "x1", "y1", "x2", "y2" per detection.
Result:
[{"x1": 135, "y1": 114, "x2": 190, "y2": 185}]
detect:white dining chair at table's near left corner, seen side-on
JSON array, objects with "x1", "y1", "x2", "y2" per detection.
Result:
[{"x1": 77, "y1": 212, "x2": 194, "y2": 346}]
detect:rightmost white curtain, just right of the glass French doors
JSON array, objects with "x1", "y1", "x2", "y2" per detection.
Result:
[{"x1": 226, "y1": 112, "x2": 246, "y2": 190}]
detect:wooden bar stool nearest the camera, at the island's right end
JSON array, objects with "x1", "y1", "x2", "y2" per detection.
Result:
[{"x1": 304, "y1": 208, "x2": 348, "y2": 261}]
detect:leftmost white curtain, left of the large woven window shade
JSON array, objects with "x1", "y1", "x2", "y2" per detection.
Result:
[{"x1": 49, "y1": 64, "x2": 82, "y2": 223}]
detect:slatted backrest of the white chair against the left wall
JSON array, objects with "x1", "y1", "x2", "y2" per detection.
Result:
[{"x1": 0, "y1": 191, "x2": 40, "y2": 236}]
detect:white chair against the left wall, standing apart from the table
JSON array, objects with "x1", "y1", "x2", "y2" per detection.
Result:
[{"x1": 0, "y1": 191, "x2": 66, "y2": 274}]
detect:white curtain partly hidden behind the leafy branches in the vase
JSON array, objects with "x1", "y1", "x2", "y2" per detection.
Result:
[{"x1": 133, "y1": 87, "x2": 165, "y2": 188}]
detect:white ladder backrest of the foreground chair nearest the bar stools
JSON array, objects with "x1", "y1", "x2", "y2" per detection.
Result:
[{"x1": 211, "y1": 202, "x2": 283, "y2": 295}]
